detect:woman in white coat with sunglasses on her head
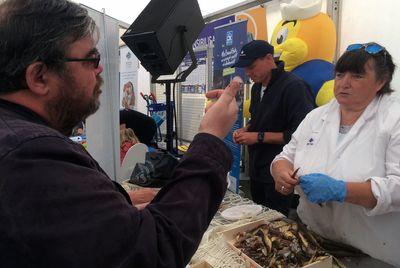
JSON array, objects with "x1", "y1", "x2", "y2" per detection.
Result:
[{"x1": 271, "y1": 43, "x2": 400, "y2": 266}]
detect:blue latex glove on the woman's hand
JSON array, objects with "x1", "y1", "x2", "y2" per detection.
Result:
[{"x1": 300, "y1": 173, "x2": 346, "y2": 203}]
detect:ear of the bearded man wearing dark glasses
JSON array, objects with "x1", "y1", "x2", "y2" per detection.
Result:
[{"x1": 25, "y1": 62, "x2": 49, "y2": 96}]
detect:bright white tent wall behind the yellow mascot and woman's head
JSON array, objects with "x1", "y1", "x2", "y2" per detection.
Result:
[{"x1": 266, "y1": 0, "x2": 400, "y2": 90}]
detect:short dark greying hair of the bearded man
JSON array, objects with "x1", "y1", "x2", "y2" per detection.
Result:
[{"x1": 0, "y1": 0, "x2": 97, "y2": 94}]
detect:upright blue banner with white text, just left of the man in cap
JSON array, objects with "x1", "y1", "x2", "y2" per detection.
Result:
[{"x1": 213, "y1": 21, "x2": 247, "y2": 193}]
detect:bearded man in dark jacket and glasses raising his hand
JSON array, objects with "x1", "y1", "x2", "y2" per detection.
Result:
[{"x1": 0, "y1": 0, "x2": 239, "y2": 267}]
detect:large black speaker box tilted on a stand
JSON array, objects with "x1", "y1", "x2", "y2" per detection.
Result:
[{"x1": 121, "y1": 0, "x2": 204, "y2": 77}]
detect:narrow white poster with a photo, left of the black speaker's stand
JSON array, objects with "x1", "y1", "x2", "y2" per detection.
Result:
[{"x1": 119, "y1": 46, "x2": 140, "y2": 110}]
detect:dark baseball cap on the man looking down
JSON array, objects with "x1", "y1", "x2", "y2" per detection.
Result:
[{"x1": 232, "y1": 40, "x2": 274, "y2": 68}]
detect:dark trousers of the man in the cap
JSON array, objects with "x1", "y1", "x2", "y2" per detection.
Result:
[{"x1": 250, "y1": 179, "x2": 293, "y2": 216}]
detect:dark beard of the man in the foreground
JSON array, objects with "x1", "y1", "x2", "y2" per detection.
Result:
[{"x1": 46, "y1": 74, "x2": 103, "y2": 136}]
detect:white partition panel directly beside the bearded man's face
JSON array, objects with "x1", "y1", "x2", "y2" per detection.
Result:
[{"x1": 85, "y1": 7, "x2": 120, "y2": 180}]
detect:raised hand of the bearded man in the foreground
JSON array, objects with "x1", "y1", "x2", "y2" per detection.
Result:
[{"x1": 199, "y1": 81, "x2": 240, "y2": 139}]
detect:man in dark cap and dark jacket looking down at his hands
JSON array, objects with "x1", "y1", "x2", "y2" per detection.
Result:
[{"x1": 233, "y1": 40, "x2": 314, "y2": 215}]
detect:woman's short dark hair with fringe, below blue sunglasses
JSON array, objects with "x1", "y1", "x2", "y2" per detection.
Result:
[{"x1": 335, "y1": 44, "x2": 396, "y2": 95}]
